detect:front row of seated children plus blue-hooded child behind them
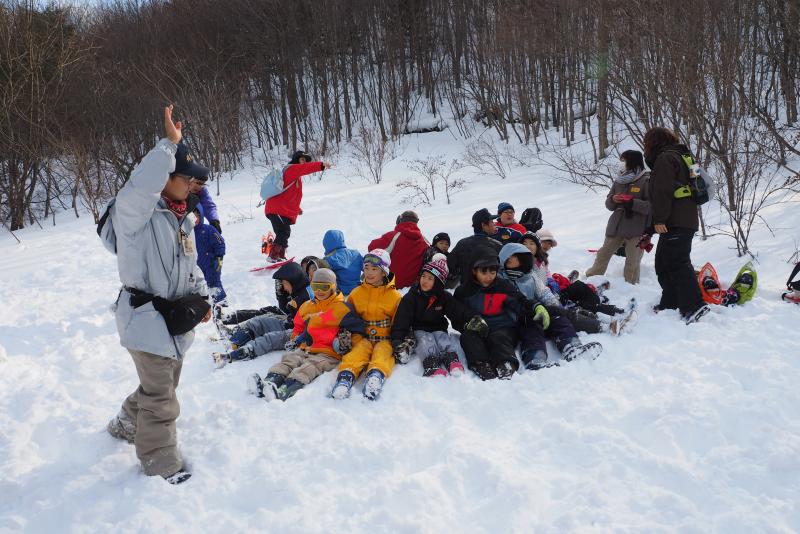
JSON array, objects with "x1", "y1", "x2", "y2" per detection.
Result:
[{"x1": 215, "y1": 208, "x2": 602, "y2": 400}]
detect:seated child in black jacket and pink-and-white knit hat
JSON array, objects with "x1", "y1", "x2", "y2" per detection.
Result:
[{"x1": 392, "y1": 254, "x2": 474, "y2": 376}]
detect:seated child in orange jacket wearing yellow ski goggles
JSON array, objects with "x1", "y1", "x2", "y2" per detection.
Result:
[{"x1": 248, "y1": 268, "x2": 364, "y2": 401}]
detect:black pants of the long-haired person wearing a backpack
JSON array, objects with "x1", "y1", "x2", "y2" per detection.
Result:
[{"x1": 656, "y1": 228, "x2": 703, "y2": 315}]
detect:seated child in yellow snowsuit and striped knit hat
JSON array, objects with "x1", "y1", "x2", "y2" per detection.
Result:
[{"x1": 331, "y1": 249, "x2": 402, "y2": 400}]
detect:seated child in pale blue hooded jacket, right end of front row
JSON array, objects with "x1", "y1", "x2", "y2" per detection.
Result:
[{"x1": 500, "y1": 243, "x2": 602, "y2": 371}]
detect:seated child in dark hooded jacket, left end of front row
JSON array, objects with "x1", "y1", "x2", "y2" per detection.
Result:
[{"x1": 213, "y1": 262, "x2": 313, "y2": 367}]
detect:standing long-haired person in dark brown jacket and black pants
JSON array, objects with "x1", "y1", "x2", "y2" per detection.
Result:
[{"x1": 644, "y1": 127, "x2": 709, "y2": 324}]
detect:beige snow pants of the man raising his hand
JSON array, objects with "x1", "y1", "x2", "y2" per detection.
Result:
[{"x1": 122, "y1": 349, "x2": 183, "y2": 477}]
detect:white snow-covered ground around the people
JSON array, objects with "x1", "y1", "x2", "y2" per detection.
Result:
[{"x1": 0, "y1": 127, "x2": 800, "y2": 533}]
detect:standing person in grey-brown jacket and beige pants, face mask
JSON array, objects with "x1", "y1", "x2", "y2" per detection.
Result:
[{"x1": 586, "y1": 150, "x2": 650, "y2": 284}]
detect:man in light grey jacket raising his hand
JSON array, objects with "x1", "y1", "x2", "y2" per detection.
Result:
[{"x1": 106, "y1": 106, "x2": 211, "y2": 484}]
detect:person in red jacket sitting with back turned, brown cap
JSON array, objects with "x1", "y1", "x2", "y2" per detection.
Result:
[{"x1": 367, "y1": 211, "x2": 430, "y2": 289}]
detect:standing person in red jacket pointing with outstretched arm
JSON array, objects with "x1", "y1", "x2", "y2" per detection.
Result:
[{"x1": 264, "y1": 150, "x2": 332, "y2": 261}]
